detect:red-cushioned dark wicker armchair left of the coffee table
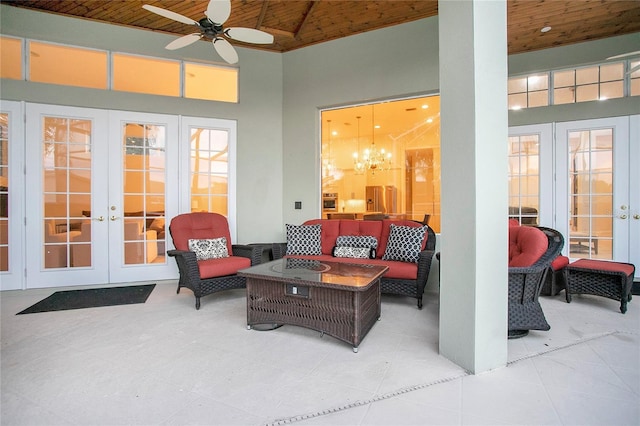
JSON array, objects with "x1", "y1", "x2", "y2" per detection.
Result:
[{"x1": 167, "y1": 212, "x2": 262, "y2": 309}]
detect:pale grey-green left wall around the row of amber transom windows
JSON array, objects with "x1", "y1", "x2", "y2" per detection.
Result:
[{"x1": 0, "y1": 4, "x2": 283, "y2": 243}]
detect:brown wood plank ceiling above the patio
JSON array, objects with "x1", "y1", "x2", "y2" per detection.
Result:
[{"x1": 3, "y1": 0, "x2": 640, "y2": 54}]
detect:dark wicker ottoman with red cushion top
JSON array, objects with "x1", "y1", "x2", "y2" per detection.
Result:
[{"x1": 565, "y1": 259, "x2": 635, "y2": 314}]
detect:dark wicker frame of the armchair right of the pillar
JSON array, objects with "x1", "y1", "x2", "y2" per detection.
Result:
[{"x1": 508, "y1": 226, "x2": 564, "y2": 339}]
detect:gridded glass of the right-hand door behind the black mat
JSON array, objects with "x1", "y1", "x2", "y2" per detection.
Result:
[{"x1": 122, "y1": 123, "x2": 167, "y2": 265}]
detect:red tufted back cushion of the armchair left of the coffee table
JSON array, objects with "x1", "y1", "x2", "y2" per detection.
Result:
[{"x1": 169, "y1": 212, "x2": 232, "y2": 254}]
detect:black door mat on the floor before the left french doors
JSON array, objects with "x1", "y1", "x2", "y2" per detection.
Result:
[{"x1": 16, "y1": 284, "x2": 156, "y2": 315}]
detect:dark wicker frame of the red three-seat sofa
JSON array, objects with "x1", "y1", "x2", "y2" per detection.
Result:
[{"x1": 272, "y1": 226, "x2": 436, "y2": 309}]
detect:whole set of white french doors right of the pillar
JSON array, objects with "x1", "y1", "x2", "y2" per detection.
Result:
[{"x1": 509, "y1": 115, "x2": 640, "y2": 265}]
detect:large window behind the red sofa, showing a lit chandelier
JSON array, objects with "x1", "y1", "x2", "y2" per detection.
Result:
[{"x1": 320, "y1": 94, "x2": 440, "y2": 232}]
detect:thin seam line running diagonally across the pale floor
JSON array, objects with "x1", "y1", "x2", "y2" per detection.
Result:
[{"x1": 265, "y1": 330, "x2": 635, "y2": 426}]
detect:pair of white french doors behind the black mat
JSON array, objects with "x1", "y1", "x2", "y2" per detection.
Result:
[{"x1": 25, "y1": 104, "x2": 179, "y2": 288}]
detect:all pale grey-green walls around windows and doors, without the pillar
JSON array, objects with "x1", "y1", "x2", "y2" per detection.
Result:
[{"x1": 0, "y1": 5, "x2": 640, "y2": 242}]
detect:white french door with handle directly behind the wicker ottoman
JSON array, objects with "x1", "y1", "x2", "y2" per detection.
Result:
[{"x1": 555, "y1": 116, "x2": 640, "y2": 264}]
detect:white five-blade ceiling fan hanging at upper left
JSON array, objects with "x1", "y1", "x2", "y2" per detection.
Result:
[{"x1": 142, "y1": 0, "x2": 273, "y2": 64}]
